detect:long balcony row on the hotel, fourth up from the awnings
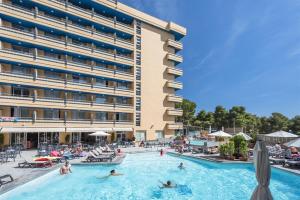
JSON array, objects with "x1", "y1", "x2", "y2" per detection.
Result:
[{"x1": 0, "y1": 49, "x2": 134, "y2": 81}]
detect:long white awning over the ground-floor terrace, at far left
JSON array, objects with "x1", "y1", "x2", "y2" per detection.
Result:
[{"x1": 0, "y1": 127, "x2": 65, "y2": 133}]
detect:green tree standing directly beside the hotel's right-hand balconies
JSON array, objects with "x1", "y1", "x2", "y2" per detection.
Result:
[{"x1": 176, "y1": 99, "x2": 197, "y2": 125}]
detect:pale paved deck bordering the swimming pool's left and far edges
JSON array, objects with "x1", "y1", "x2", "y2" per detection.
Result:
[{"x1": 0, "y1": 147, "x2": 300, "y2": 195}]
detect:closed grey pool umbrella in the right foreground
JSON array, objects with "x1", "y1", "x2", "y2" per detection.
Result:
[{"x1": 251, "y1": 141, "x2": 273, "y2": 200}]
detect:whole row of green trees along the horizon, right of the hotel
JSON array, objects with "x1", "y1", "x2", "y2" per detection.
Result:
[{"x1": 177, "y1": 99, "x2": 300, "y2": 135}]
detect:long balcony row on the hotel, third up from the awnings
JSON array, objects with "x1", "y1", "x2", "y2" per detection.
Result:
[{"x1": 0, "y1": 72, "x2": 134, "y2": 97}]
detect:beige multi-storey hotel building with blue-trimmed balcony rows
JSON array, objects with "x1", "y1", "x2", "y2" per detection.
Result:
[{"x1": 0, "y1": 0, "x2": 186, "y2": 148}]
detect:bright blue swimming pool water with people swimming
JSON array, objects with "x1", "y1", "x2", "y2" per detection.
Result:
[{"x1": 0, "y1": 153, "x2": 300, "y2": 200}]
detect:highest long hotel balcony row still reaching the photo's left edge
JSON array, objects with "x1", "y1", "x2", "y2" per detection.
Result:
[{"x1": 0, "y1": 1, "x2": 134, "y2": 50}]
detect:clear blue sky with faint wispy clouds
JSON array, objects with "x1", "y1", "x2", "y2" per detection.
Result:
[{"x1": 121, "y1": 0, "x2": 300, "y2": 117}]
